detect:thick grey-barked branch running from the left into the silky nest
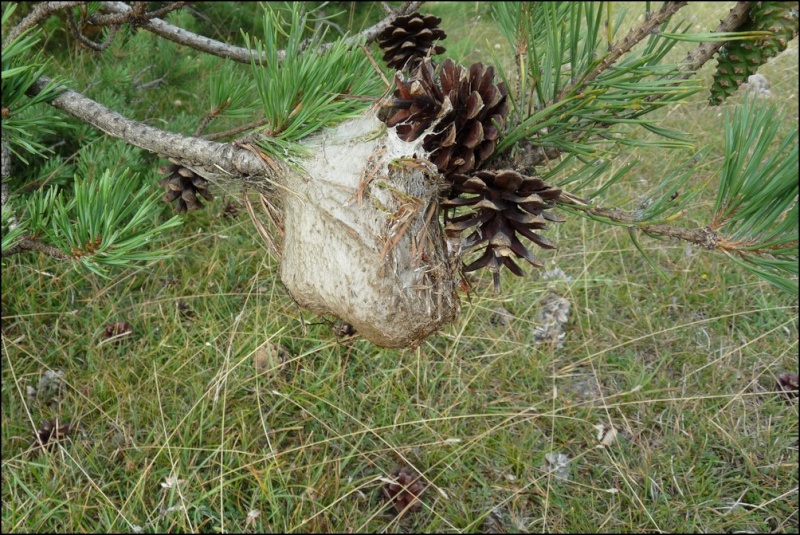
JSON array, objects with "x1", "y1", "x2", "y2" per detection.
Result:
[{"x1": 28, "y1": 76, "x2": 277, "y2": 184}]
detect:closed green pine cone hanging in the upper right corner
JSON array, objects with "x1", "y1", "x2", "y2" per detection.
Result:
[{"x1": 709, "y1": 2, "x2": 798, "y2": 106}]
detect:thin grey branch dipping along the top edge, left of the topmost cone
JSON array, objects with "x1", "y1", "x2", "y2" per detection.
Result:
[{"x1": 92, "y1": 2, "x2": 422, "y2": 64}]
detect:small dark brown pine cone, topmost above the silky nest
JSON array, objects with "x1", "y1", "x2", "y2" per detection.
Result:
[{"x1": 378, "y1": 13, "x2": 447, "y2": 71}]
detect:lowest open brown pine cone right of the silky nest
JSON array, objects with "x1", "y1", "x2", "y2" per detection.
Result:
[{"x1": 441, "y1": 170, "x2": 561, "y2": 291}]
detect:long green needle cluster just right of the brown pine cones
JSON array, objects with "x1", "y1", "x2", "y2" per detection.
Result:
[{"x1": 493, "y1": 2, "x2": 700, "y2": 158}]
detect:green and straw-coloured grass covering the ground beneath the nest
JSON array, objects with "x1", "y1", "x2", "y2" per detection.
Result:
[{"x1": 2, "y1": 4, "x2": 799, "y2": 532}]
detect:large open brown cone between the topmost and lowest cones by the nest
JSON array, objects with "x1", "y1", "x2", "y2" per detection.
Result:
[{"x1": 386, "y1": 59, "x2": 508, "y2": 177}]
